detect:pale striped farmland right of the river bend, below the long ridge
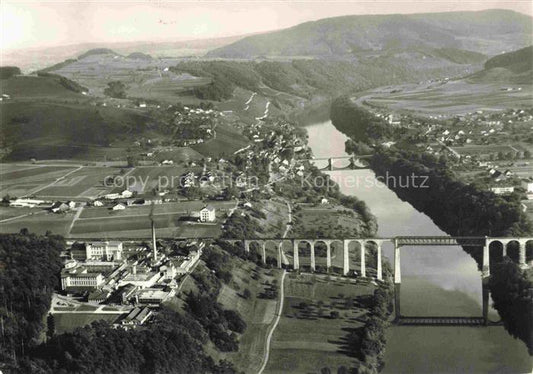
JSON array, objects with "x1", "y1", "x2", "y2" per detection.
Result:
[{"x1": 357, "y1": 80, "x2": 533, "y2": 116}]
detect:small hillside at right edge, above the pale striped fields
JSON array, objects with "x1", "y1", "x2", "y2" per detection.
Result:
[{"x1": 468, "y1": 46, "x2": 533, "y2": 84}]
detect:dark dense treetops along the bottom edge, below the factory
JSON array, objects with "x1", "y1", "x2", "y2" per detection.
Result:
[{"x1": 26, "y1": 308, "x2": 233, "y2": 374}]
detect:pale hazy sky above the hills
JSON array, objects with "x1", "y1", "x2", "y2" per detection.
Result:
[{"x1": 0, "y1": 0, "x2": 533, "y2": 51}]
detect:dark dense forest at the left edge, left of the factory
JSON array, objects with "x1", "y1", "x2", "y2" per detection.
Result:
[{"x1": 0, "y1": 230, "x2": 65, "y2": 369}]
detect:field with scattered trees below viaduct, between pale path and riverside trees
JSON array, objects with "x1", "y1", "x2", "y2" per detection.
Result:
[{"x1": 265, "y1": 274, "x2": 374, "y2": 373}]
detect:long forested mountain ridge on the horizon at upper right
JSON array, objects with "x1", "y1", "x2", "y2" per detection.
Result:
[{"x1": 208, "y1": 10, "x2": 532, "y2": 58}]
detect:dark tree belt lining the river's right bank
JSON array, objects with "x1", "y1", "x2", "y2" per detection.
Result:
[{"x1": 331, "y1": 98, "x2": 533, "y2": 355}]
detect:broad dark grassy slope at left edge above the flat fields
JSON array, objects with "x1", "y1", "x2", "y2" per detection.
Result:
[{"x1": 1, "y1": 76, "x2": 149, "y2": 160}]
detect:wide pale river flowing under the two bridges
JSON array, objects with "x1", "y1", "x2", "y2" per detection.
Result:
[{"x1": 306, "y1": 121, "x2": 531, "y2": 373}]
